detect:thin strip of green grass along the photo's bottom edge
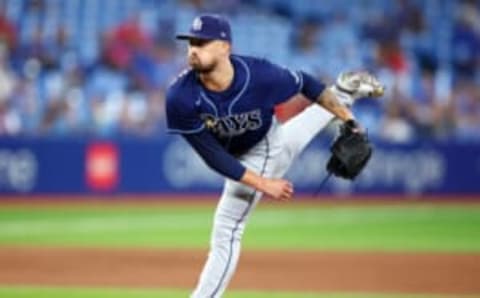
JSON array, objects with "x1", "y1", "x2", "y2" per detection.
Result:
[{"x1": 0, "y1": 287, "x2": 473, "y2": 298}]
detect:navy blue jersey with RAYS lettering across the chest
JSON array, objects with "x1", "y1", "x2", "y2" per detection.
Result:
[{"x1": 166, "y1": 55, "x2": 324, "y2": 155}]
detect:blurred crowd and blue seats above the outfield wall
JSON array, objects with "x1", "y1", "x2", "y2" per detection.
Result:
[{"x1": 0, "y1": 0, "x2": 480, "y2": 143}]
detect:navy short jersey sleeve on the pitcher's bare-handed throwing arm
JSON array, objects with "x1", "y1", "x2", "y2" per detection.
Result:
[{"x1": 166, "y1": 89, "x2": 205, "y2": 134}]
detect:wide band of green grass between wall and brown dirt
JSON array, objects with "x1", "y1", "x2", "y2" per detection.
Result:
[{"x1": 0, "y1": 204, "x2": 480, "y2": 252}]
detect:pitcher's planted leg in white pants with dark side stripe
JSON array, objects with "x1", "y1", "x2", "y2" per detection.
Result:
[{"x1": 191, "y1": 181, "x2": 261, "y2": 298}]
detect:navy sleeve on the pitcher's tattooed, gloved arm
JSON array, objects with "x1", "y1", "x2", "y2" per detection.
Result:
[{"x1": 263, "y1": 61, "x2": 325, "y2": 105}]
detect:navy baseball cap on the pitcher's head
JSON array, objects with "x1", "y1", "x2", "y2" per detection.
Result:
[{"x1": 176, "y1": 14, "x2": 232, "y2": 42}]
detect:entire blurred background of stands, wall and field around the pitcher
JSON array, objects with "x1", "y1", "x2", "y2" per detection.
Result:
[{"x1": 0, "y1": 0, "x2": 480, "y2": 298}]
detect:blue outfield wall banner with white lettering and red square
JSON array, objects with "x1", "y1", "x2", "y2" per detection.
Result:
[{"x1": 0, "y1": 137, "x2": 480, "y2": 195}]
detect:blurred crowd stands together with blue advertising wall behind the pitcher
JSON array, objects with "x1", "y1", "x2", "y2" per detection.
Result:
[{"x1": 0, "y1": 0, "x2": 480, "y2": 194}]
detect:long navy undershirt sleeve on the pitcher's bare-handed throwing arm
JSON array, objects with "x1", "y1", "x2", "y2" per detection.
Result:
[{"x1": 182, "y1": 130, "x2": 246, "y2": 181}]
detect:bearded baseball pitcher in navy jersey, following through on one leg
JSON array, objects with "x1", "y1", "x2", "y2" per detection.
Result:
[{"x1": 166, "y1": 14, "x2": 383, "y2": 298}]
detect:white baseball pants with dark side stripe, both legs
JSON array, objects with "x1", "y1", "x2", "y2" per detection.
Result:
[{"x1": 191, "y1": 104, "x2": 334, "y2": 298}]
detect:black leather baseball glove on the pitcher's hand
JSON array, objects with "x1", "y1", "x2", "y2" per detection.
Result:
[{"x1": 327, "y1": 120, "x2": 373, "y2": 180}]
